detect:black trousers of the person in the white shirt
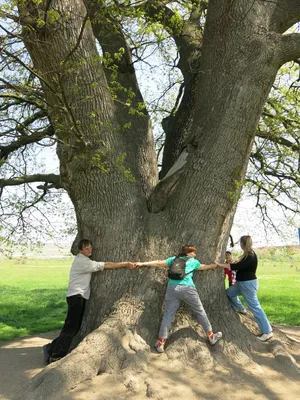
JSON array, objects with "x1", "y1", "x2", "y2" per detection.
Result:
[{"x1": 48, "y1": 294, "x2": 86, "y2": 358}]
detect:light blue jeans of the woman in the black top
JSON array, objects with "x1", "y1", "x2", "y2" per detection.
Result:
[{"x1": 226, "y1": 279, "x2": 272, "y2": 333}]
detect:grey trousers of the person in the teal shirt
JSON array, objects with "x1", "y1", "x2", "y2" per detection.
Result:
[{"x1": 158, "y1": 285, "x2": 212, "y2": 339}]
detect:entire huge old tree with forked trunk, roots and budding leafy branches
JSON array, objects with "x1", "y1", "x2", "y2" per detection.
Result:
[{"x1": 1, "y1": 0, "x2": 300, "y2": 399}]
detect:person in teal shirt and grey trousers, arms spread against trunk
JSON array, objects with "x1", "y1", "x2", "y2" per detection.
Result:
[{"x1": 136, "y1": 245, "x2": 222, "y2": 353}]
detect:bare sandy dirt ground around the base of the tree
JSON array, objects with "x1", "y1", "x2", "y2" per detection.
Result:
[{"x1": 0, "y1": 326, "x2": 300, "y2": 400}]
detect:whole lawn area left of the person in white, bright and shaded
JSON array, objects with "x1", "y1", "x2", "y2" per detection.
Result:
[{"x1": 0, "y1": 259, "x2": 72, "y2": 340}]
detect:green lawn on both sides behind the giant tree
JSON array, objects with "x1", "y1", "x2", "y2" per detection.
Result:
[{"x1": 0, "y1": 249, "x2": 300, "y2": 341}]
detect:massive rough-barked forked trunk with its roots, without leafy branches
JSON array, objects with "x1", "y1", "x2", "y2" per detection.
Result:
[{"x1": 13, "y1": 0, "x2": 300, "y2": 400}]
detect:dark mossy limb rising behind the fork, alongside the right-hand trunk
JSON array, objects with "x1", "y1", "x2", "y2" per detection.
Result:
[{"x1": 139, "y1": 0, "x2": 207, "y2": 177}]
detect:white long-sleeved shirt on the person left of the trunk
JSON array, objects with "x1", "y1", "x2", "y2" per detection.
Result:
[{"x1": 67, "y1": 253, "x2": 104, "y2": 300}]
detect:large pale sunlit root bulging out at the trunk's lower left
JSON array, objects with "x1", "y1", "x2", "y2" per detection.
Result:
[{"x1": 14, "y1": 318, "x2": 149, "y2": 400}]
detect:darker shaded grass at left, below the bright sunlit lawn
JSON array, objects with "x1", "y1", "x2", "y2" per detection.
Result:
[{"x1": 0, "y1": 286, "x2": 67, "y2": 341}]
